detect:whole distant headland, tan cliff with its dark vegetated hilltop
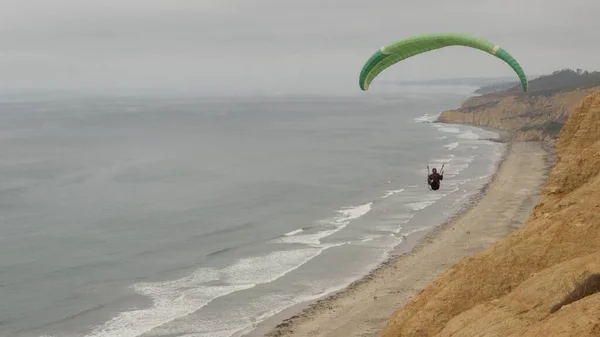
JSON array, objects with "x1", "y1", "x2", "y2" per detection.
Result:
[{"x1": 438, "y1": 69, "x2": 600, "y2": 141}]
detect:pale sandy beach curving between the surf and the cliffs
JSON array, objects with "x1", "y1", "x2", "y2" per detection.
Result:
[{"x1": 248, "y1": 142, "x2": 554, "y2": 337}]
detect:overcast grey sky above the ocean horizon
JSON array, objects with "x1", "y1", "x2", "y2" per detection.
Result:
[{"x1": 0, "y1": 0, "x2": 600, "y2": 94}]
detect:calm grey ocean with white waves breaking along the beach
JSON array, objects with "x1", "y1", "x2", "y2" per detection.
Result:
[{"x1": 0, "y1": 86, "x2": 505, "y2": 337}]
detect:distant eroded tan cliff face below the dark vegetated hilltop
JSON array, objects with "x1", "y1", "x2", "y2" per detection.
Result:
[{"x1": 439, "y1": 87, "x2": 600, "y2": 141}]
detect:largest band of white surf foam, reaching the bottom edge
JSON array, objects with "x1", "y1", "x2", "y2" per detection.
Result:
[{"x1": 87, "y1": 245, "x2": 333, "y2": 337}]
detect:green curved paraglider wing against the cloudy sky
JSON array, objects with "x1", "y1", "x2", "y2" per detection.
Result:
[{"x1": 359, "y1": 33, "x2": 527, "y2": 92}]
